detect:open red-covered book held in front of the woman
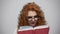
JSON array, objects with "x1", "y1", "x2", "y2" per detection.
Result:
[{"x1": 18, "y1": 25, "x2": 49, "y2": 34}]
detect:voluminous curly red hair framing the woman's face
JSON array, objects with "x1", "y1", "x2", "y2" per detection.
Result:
[{"x1": 18, "y1": 2, "x2": 46, "y2": 29}]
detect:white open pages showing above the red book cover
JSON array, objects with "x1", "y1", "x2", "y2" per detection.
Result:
[{"x1": 18, "y1": 25, "x2": 48, "y2": 31}]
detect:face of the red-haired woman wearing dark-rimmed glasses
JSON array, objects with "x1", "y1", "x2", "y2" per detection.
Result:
[{"x1": 28, "y1": 11, "x2": 38, "y2": 27}]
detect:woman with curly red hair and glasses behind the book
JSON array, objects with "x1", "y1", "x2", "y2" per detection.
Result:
[{"x1": 13, "y1": 2, "x2": 46, "y2": 34}]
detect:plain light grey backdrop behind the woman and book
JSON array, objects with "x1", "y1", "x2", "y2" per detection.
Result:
[{"x1": 0, "y1": 0, "x2": 60, "y2": 34}]
